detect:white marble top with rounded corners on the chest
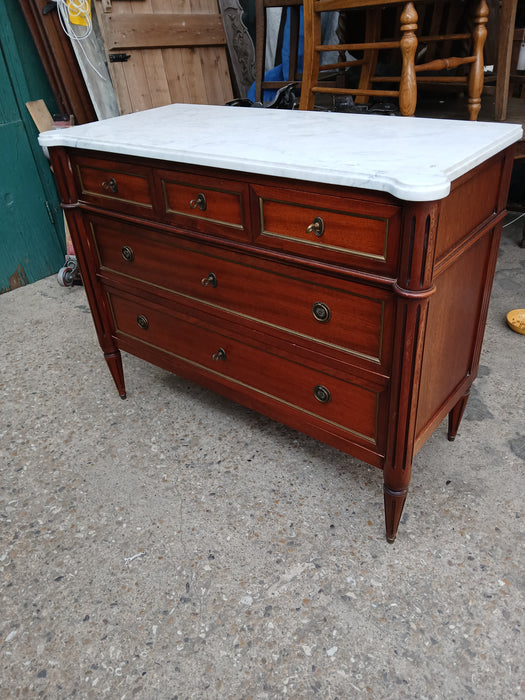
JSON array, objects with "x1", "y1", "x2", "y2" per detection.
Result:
[{"x1": 39, "y1": 104, "x2": 522, "y2": 201}]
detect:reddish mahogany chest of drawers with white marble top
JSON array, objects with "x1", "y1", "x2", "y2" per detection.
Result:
[{"x1": 41, "y1": 105, "x2": 519, "y2": 541}]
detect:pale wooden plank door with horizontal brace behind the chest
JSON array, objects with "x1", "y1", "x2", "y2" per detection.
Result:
[{"x1": 94, "y1": 0, "x2": 233, "y2": 113}]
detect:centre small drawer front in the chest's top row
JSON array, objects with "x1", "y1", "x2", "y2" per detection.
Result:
[{"x1": 156, "y1": 170, "x2": 250, "y2": 240}]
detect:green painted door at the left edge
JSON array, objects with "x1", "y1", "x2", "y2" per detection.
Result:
[{"x1": 0, "y1": 0, "x2": 65, "y2": 293}]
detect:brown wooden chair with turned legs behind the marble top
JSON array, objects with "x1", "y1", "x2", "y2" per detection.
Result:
[{"x1": 300, "y1": 0, "x2": 489, "y2": 120}]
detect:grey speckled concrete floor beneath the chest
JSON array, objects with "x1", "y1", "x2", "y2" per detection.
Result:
[{"x1": 0, "y1": 214, "x2": 525, "y2": 700}]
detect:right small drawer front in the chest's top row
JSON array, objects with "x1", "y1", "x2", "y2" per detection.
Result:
[{"x1": 253, "y1": 186, "x2": 400, "y2": 274}]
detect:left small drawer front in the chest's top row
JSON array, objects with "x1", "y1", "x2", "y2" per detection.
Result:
[{"x1": 73, "y1": 156, "x2": 153, "y2": 218}]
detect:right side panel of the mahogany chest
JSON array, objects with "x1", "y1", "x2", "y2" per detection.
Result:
[{"x1": 417, "y1": 153, "x2": 512, "y2": 448}]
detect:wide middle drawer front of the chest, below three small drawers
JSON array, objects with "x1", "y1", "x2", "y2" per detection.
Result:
[{"x1": 91, "y1": 219, "x2": 392, "y2": 371}]
